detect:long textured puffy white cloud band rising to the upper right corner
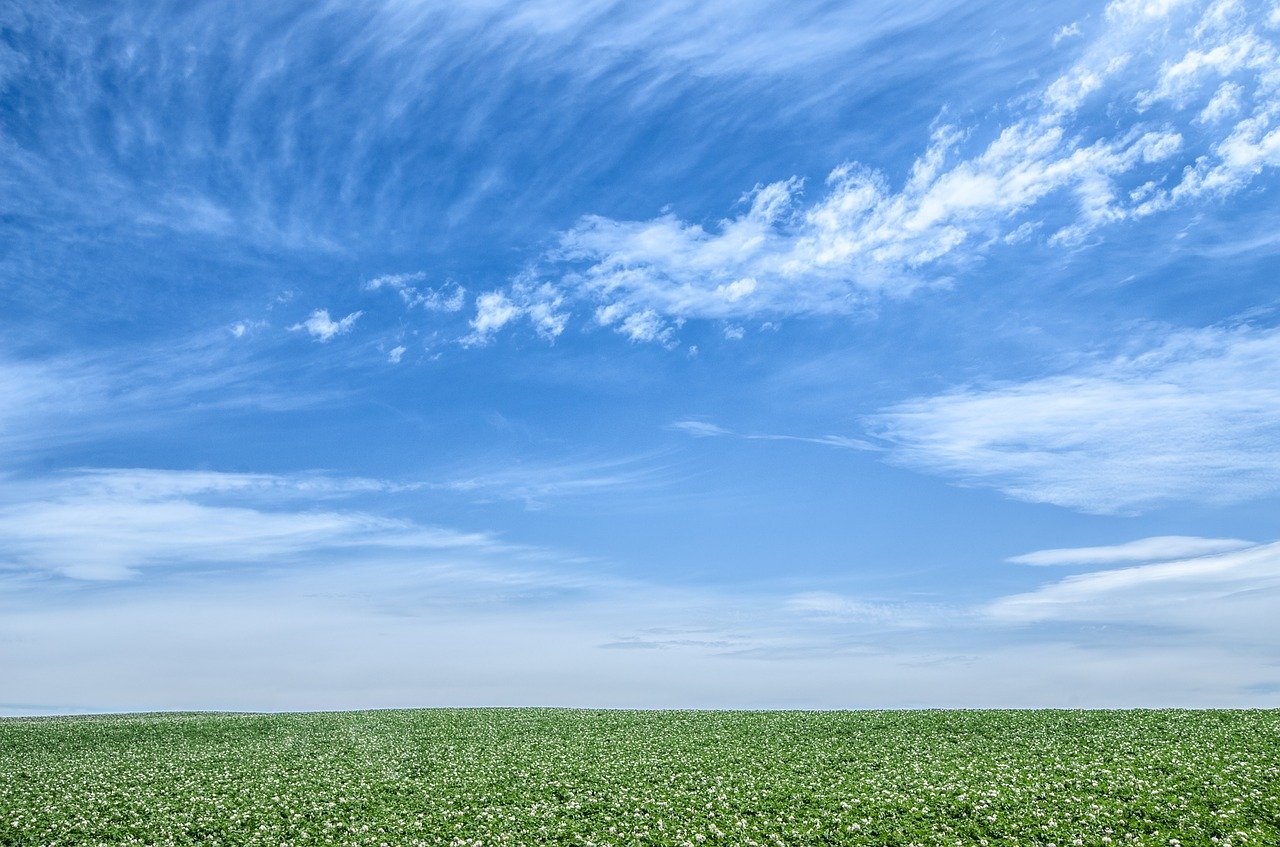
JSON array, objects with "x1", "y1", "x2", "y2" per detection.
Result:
[{"x1": 478, "y1": 0, "x2": 1280, "y2": 343}]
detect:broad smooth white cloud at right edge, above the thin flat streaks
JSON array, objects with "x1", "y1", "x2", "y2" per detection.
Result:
[{"x1": 868, "y1": 328, "x2": 1280, "y2": 513}]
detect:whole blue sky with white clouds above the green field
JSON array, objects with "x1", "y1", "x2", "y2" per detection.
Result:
[{"x1": 0, "y1": 0, "x2": 1280, "y2": 715}]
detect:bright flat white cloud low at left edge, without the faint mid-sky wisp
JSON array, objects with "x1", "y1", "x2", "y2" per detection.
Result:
[{"x1": 0, "y1": 470, "x2": 515, "y2": 580}]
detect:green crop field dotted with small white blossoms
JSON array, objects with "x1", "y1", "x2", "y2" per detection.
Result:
[{"x1": 0, "y1": 709, "x2": 1280, "y2": 847}]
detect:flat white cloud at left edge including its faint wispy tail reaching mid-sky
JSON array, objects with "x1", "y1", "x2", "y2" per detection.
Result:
[{"x1": 0, "y1": 462, "x2": 663, "y2": 581}]
